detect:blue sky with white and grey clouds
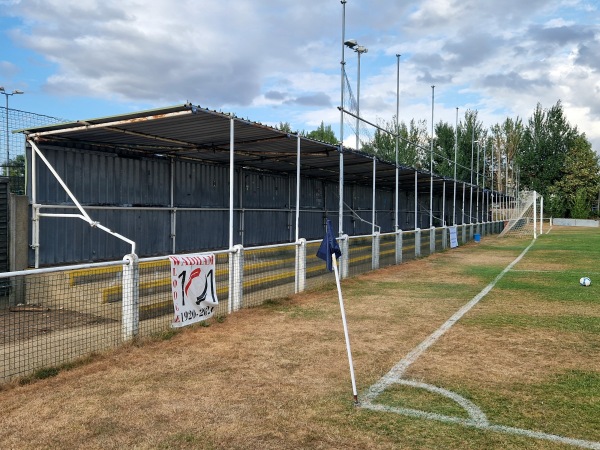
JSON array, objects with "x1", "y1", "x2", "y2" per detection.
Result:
[{"x1": 0, "y1": 0, "x2": 600, "y2": 152}]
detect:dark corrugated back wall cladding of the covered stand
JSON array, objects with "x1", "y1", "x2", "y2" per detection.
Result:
[{"x1": 28, "y1": 146, "x2": 451, "y2": 265}]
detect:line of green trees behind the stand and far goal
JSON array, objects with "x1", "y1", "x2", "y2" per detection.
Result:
[{"x1": 286, "y1": 101, "x2": 600, "y2": 219}]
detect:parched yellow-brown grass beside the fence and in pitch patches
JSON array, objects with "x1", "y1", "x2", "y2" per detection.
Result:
[{"x1": 0, "y1": 236, "x2": 600, "y2": 449}]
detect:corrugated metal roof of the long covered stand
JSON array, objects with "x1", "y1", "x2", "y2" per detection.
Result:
[{"x1": 20, "y1": 103, "x2": 478, "y2": 192}]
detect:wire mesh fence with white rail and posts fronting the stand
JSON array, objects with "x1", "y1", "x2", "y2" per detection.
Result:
[{"x1": 0, "y1": 222, "x2": 496, "y2": 381}]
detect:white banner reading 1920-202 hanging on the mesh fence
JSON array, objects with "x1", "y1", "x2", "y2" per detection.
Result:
[{"x1": 169, "y1": 253, "x2": 219, "y2": 328}]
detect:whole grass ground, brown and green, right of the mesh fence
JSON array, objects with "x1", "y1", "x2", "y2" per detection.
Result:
[{"x1": 0, "y1": 227, "x2": 600, "y2": 450}]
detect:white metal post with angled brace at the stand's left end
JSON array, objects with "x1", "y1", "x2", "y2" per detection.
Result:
[{"x1": 28, "y1": 139, "x2": 135, "y2": 269}]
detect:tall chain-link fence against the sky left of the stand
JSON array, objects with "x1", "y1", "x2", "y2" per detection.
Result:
[{"x1": 0, "y1": 106, "x2": 67, "y2": 195}]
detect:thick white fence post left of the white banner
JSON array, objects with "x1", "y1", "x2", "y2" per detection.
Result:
[{"x1": 121, "y1": 253, "x2": 140, "y2": 341}]
